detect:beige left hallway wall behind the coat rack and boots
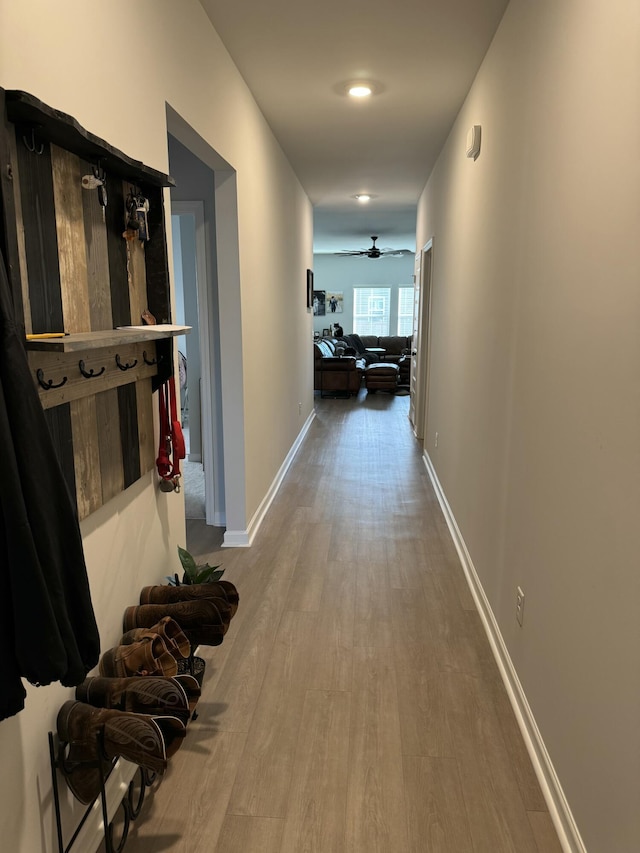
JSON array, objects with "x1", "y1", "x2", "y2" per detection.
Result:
[{"x1": 0, "y1": 0, "x2": 313, "y2": 853}]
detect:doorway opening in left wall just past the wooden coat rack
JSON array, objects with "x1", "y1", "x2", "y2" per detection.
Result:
[{"x1": 167, "y1": 105, "x2": 248, "y2": 546}]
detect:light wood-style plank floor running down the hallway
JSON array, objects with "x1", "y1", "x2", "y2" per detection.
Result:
[{"x1": 126, "y1": 392, "x2": 560, "y2": 853}]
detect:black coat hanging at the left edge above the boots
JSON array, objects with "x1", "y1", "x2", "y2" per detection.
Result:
[{"x1": 0, "y1": 254, "x2": 100, "y2": 719}]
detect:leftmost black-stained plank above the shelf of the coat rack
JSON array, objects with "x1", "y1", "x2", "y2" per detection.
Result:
[{"x1": 16, "y1": 127, "x2": 64, "y2": 334}]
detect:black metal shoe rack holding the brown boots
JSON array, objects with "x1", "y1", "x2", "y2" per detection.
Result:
[{"x1": 49, "y1": 732, "x2": 156, "y2": 853}]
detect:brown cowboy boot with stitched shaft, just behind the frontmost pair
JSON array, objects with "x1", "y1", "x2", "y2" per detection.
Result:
[{"x1": 76, "y1": 676, "x2": 195, "y2": 725}]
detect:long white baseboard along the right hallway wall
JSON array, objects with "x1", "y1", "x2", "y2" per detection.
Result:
[{"x1": 422, "y1": 451, "x2": 587, "y2": 853}]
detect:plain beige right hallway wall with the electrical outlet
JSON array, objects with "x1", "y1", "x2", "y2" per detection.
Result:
[{"x1": 417, "y1": 0, "x2": 640, "y2": 853}]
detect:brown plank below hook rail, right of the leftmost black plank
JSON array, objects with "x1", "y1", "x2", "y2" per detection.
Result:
[{"x1": 70, "y1": 396, "x2": 102, "y2": 519}]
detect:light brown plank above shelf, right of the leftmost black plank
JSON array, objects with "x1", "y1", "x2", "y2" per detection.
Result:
[{"x1": 51, "y1": 145, "x2": 91, "y2": 332}]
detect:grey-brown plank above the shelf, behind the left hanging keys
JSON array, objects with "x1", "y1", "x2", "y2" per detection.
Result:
[{"x1": 81, "y1": 160, "x2": 113, "y2": 332}]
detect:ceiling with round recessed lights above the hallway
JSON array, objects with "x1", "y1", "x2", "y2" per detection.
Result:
[{"x1": 200, "y1": 0, "x2": 508, "y2": 252}]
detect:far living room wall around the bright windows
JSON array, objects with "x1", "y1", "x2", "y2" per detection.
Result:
[{"x1": 313, "y1": 254, "x2": 414, "y2": 335}]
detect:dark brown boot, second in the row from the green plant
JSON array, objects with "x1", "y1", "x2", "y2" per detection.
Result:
[{"x1": 123, "y1": 598, "x2": 229, "y2": 646}]
